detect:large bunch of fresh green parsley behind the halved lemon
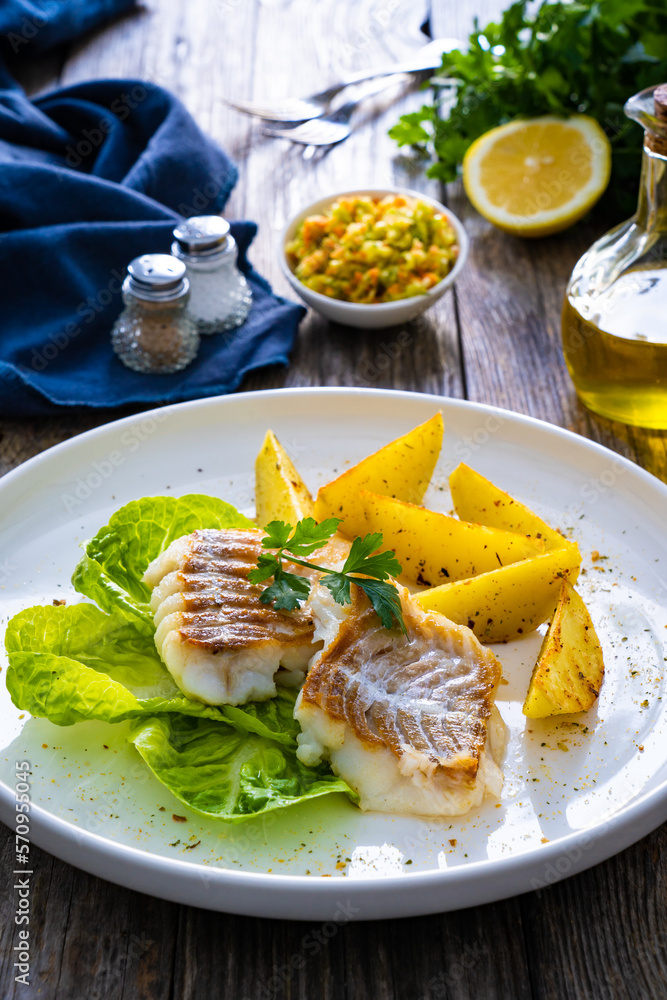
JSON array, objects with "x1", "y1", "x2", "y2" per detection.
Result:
[{"x1": 389, "y1": 0, "x2": 667, "y2": 214}]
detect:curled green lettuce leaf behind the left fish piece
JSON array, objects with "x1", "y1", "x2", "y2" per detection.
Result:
[{"x1": 72, "y1": 493, "x2": 256, "y2": 635}]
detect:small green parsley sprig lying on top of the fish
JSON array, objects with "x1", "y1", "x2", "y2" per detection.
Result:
[{"x1": 248, "y1": 517, "x2": 407, "y2": 632}]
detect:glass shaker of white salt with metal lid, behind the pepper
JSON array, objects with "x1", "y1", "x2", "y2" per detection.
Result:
[{"x1": 171, "y1": 215, "x2": 252, "y2": 334}]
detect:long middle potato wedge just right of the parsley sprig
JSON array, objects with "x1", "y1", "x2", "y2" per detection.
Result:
[{"x1": 359, "y1": 490, "x2": 544, "y2": 587}]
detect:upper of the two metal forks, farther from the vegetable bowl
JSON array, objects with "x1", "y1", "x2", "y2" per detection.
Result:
[{"x1": 225, "y1": 38, "x2": 463, "y2": 124}]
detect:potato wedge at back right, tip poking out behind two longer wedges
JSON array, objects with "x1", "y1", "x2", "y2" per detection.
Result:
[{"x1": 449, "y1": 463, "x2": 576, "y2": 552}]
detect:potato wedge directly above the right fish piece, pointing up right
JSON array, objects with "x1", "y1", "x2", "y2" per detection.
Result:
[{"x1": 416, "y1": 545, "x2": 581, "y2": 642}]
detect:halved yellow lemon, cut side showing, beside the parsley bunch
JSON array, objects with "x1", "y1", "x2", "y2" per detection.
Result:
[{"x1": 463, "y1": 115, "x2": 611, "y2": 236}]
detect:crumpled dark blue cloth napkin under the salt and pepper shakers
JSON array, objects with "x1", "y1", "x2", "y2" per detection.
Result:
[{"x1": 0, "y1": 0, "x2": 305, "y2": 416}]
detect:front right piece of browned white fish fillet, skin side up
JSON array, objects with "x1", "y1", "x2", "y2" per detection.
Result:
[{"x1": 294, "y1": 586, "x2": 505, "y2": 816}]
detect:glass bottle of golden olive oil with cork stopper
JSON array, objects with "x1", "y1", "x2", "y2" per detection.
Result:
[{"x1": 562, "y1": 84, "x2": 667, "y2": 428}]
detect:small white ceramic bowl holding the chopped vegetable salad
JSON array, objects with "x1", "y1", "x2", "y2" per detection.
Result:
[{"x1": 280, "y1": 188, "x2": 468, "y2": 329}]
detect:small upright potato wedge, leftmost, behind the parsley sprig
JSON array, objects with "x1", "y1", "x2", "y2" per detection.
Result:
[{"x1": 255, "y1": 430, "x2": 314, "y2": 527}]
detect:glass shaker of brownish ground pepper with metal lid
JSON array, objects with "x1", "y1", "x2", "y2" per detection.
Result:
[{"x1": 111, "y1": 253, "x2": 199, "y2": 375}]
